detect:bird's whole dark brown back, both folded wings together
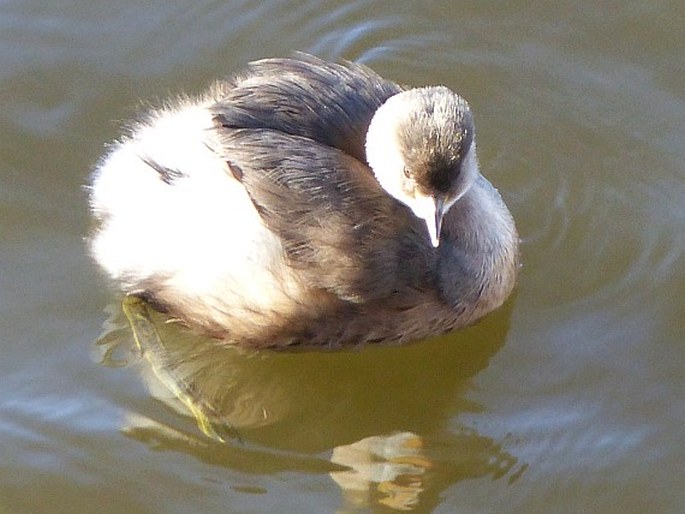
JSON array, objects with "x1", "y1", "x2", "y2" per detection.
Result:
[{"x1": 211, "y1": 54, "x2": 430, "y2": 303}]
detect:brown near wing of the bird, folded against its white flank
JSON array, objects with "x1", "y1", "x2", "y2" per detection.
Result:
[{"x1": 215, "y1": 127, "x2": 429, "y2": 302}]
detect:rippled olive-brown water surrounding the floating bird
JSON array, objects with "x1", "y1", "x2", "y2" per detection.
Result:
[{"x1": 0, "y1": 0, "x2": 685, "y2": 514}]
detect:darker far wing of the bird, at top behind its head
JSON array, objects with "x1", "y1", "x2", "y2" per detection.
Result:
[{"x1": 212, "y1": 54, "x2": 402, "y2": 162}]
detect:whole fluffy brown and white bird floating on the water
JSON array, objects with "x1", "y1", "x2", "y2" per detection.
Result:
[{"x1": 91, "y1": 56, "x2": 518, "y2": 347}]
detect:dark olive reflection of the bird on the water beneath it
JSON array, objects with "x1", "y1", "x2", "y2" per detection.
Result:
[{"x1": 96, "y1": 296, "x2": 523, "y2": 510}]
